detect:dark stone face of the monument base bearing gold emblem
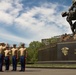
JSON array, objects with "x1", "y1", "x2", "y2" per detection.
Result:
[{"x1": 57, "y1": 41, "x2": 76, "y2": 60}]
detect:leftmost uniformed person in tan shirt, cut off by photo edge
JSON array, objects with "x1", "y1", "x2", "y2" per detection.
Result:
[{"x1": 0, "y1": 43, "x2": 6, "y2": 72}]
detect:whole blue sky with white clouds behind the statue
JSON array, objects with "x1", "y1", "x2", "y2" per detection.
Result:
[{"x1": 0, "y1": 0, "x2": 72, "y2": 46}]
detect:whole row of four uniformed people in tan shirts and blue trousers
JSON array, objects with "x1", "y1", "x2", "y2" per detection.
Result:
[{"x1": 0, "y1": 43, "x2": 27, "y2": 72}]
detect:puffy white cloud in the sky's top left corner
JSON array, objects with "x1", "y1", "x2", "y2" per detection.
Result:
[{"x1": 0, "y1": 0, "x2": 22, "y2": 25}]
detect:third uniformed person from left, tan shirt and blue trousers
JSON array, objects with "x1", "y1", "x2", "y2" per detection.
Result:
[{"x1": 11, "y1": 44, "x2": 18, "y2": 71}]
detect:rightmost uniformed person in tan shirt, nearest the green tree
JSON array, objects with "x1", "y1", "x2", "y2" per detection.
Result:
[{"x1": 19, "y1": 44, "x2": 27, "y2": 72}]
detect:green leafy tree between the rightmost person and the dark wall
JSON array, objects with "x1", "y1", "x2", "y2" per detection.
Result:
[{"x1": 27, "y1": 41, "x2": 44, "y2": 63}]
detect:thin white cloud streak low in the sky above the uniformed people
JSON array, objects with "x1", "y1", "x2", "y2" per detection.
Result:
[{"x1": 0, "y1": 28, "x2": 30, "y2": 44}]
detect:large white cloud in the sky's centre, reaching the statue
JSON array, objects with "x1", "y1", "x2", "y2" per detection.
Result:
[{"x1": 15, "y1": 3, "x2": 71, "y2": 39}]
